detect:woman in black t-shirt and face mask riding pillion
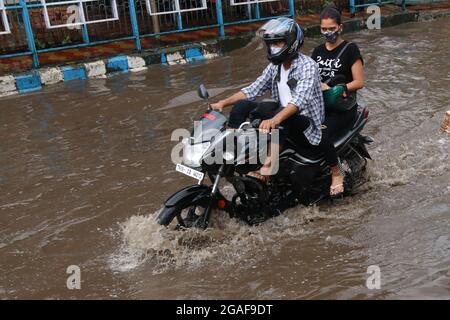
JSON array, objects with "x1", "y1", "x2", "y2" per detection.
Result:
[{"x1": 312, "y1": 6, "x2": 364, "y2": 196}]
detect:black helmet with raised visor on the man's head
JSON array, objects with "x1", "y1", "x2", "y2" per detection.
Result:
[{"x1": 258, "y1": 18, "x2": 304, "y2": 65}]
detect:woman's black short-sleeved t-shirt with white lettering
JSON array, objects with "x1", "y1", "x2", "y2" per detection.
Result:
[{"x1": 311, "y1": 40, "x2": 364, "y2": 83}]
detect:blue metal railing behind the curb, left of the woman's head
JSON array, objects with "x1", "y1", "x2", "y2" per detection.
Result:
[{"x1": 0, "y1": 0, "x2": 295, "y2": 68}]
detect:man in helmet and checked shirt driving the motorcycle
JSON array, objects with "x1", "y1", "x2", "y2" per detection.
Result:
[{"x1": 212, "y1": 18, "x2": 342, "y2": 198}]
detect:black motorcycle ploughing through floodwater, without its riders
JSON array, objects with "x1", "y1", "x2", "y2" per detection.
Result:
[{"x1": 157, "y1": 85, "x2": 373, "y2": 229}]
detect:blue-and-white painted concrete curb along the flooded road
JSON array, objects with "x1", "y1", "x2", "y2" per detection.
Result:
[{"x1": 0, "y1": 10, "x2": 450, "y2": 97}]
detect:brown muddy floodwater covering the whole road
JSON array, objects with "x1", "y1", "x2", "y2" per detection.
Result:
[{"x1": 0, "y1": 19, "x2": 450, "y2": 299}]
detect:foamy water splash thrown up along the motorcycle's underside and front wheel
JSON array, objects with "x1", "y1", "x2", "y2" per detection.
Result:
[{"x1": 110, "y1": 207, "x2": 325, "y2": 274}]
